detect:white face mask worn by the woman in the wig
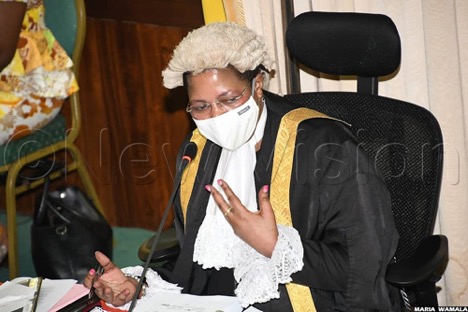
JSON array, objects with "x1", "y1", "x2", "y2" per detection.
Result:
[{"x1": 193, "y1": 96, "x2": 259, "y2": 151}]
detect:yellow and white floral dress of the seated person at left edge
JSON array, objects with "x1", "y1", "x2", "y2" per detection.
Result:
[{"x1": 0, "y1": 0, "x2": 78, "y2": 145}]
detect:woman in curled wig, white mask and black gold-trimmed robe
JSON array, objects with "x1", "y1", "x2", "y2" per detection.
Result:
[{"x1": 84, "y1": 23, "x2": 398, "y2": 312}]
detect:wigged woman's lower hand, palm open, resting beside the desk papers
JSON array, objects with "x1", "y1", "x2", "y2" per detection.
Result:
[{"x1": 83, "y1": 251, "x2": 138, "y2": 306}]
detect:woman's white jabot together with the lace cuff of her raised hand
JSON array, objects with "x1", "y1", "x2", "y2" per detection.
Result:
[{"x1": 193, "y1": 105, "x2": 303, "y2": 307}]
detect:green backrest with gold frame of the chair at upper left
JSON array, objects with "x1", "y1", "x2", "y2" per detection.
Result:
[{"x1": 44, "y1": 0, "x2": 86, "y2": 142}]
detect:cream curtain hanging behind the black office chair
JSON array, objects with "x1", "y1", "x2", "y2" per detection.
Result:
[{"x1": 199, "y1": 0, "x2": 468, "y2": 306}]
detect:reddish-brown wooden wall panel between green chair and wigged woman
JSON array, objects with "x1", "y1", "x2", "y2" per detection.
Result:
[{"x1": 77, "y1": 18, "x2": 196, "y2": 229}]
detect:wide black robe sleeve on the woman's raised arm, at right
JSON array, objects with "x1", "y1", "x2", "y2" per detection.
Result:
[{"x1": 290, "y1": 119, "x2": 398, "y2": 309}]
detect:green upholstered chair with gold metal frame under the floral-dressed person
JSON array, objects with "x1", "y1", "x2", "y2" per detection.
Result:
[{"x1": 0, "y1": 0, "x2": 102, "y2": 279}]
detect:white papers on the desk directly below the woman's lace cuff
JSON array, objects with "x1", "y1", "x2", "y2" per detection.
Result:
[{"x1": 134, "y1": 292, "x2": 259, "y2": 312}]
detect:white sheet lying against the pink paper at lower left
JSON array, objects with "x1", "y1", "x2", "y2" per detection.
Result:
[{"x1": 37, "y1": 279, "x2": 77, "y2": 311}]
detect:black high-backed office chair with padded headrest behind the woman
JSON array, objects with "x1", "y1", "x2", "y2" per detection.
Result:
[{"x1": 286, "y1": 12, "x2": 448, "y2": 310}]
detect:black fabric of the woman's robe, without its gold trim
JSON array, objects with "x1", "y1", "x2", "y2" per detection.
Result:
[{"x1": 166, "y1": 92, "x2": 399, "y2": 312}]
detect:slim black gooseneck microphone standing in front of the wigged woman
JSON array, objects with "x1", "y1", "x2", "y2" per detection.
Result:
[{"x1": 128, "y1": 142, "x2": 197, "y2": 312}]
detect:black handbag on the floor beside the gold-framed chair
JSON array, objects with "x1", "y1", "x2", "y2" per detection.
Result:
[{"x1": 31, "y1": 179, "x2": 112, "y2": 282}]
